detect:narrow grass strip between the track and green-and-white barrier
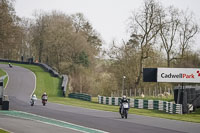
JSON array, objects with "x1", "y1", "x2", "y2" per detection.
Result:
[{"x1": 49, "y1": 97, "x2": 200, "y2": 123}]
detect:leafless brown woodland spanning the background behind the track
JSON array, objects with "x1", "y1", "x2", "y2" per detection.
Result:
[{"x1": 0, "y1": 0, "x2": 200, "y2": 96}]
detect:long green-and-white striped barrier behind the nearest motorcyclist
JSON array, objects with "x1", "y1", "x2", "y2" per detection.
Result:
[{"x1": 98, "y1": 96, "x2": 182, "y2": 114}]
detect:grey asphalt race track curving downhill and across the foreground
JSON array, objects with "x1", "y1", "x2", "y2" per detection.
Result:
[{"x1": 0, "y1": 64, "x2": 200, "y2": 133}]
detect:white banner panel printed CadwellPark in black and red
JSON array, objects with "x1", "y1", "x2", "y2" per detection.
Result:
[{"x1": 157, "y1": 68, "x2": 200, "y2": 83}]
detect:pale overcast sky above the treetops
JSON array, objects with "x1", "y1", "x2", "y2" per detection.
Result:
[{"x1": 15, "y1": 0, "x2": 200, "y2": 48}]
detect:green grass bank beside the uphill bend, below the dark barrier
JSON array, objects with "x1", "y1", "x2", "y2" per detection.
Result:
[{"x1": 0, "y1": 63, "x2": 62, "y2": 98}]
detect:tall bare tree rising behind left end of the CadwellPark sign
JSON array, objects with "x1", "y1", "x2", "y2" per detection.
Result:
[{"x1": 129, "y1": 0, "x2": 161, "y2": 87}]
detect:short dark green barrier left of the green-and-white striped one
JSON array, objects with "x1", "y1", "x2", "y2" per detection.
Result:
[{"x1": 68, "y1": 93, "x2": 91, "y2": 103}]
